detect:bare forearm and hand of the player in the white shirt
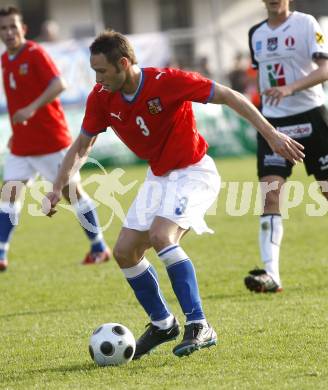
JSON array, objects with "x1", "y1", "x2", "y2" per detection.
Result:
[{"x1": 263, "y1": 58, "x2": 328, "y2": 106}]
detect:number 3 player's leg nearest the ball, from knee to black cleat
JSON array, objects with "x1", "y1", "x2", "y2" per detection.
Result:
[{"x1": 113, "y1": 227, "x2": 180, "y2": 359}]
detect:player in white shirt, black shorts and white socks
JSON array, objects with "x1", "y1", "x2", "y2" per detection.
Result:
[{"x1": 245, "y1": 0, "x2": 328, "y2": 292}]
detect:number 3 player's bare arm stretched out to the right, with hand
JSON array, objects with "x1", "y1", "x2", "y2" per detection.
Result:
[{"x1": 211, "y1": 84, "x2": 304, "y2": 164}]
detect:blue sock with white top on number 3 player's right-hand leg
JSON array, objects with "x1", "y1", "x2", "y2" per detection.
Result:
[{"x1": 158, "y1": 245, "x2": 205, "y2": 322}]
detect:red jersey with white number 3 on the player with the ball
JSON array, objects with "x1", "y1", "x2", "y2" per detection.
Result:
[{"x1": 82, "y1": 68, "x2": 214, "y2": 176}]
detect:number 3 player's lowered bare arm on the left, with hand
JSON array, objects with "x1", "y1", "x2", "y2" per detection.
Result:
[{"x1": 42, "y1": 133, "x2": 97, "y2": 217}]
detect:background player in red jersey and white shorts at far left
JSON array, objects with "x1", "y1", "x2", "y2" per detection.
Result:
[{"x1": 0, "y1": 7, "x2": 109, "y2": 271}]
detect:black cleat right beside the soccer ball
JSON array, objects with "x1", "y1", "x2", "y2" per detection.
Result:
[{"x1": 133, "y1": 318, "x2": 180, "y2": 360}]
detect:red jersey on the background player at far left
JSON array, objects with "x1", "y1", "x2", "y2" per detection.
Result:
[{"x1": 1, "y1": 41, "x2": 71, "y2": 156}]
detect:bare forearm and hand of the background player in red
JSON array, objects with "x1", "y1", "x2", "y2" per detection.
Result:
[{"x1": 12, "y1": 77, "x2": 66, "y2": 124}]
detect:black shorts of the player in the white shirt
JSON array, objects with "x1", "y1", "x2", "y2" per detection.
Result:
[{"x1": 257, "y1": 106, "x2": 328, "y2": 180}]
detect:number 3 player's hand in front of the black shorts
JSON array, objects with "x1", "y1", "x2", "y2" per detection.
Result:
[{"x1": 267, "y1": 130, "x2": 305, "y2": 164}]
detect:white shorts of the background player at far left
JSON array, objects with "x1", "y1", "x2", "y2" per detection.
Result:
[{"x1": 3, "y1": 148, "x2": 80, "y2": 183}]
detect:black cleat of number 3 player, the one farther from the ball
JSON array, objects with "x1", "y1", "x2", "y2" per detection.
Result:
[{"x1": 173, "y1": 323, "x2": 217, "y2": 357}]
